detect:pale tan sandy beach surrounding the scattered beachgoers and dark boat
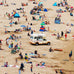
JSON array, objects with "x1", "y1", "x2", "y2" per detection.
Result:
[{"x1": 0, "y1": 0, "x2": 74, "y2": 74}]
